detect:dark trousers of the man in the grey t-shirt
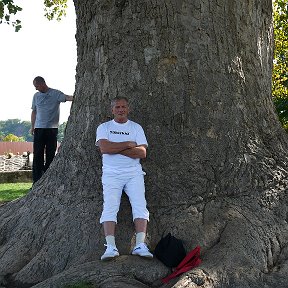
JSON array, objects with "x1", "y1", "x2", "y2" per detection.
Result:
[{"x1": 33, "y1": 128, "x2": 58, "y2": 183}]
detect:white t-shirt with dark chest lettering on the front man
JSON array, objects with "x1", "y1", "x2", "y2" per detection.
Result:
[{"x1": 96, "y1": 120, "x2": 148, "y2": 176}]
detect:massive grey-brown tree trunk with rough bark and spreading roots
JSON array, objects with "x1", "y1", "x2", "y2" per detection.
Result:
[{"x1": 0, "y1": 0, "x2": 288, "y2": 288}]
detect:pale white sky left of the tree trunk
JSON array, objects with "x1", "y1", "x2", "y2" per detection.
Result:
[{"x1": 0, "y1": 0, "x2": 77, "y2": 123}]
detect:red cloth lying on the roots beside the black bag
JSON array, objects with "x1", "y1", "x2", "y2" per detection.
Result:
[{"x1": 162, "y1": 246, "x2": 202, "y2": 283}]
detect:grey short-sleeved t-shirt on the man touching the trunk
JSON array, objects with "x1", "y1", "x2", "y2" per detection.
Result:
[{"x1": 32, "y1": 88, "x2": 66, "y2": 128}]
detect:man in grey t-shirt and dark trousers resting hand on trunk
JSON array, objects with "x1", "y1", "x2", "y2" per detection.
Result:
[{"x1": 31, "y1": 76, "x2": 73, "y2": 183}]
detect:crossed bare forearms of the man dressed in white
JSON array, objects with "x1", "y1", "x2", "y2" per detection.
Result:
[{"x1": 98, "y1": 139, "x2": 147, "y2": 159}]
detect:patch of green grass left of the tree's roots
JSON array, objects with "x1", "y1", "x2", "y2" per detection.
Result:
[{"x1": 0, "y1": 183, "x2": 32, "y2": 202}]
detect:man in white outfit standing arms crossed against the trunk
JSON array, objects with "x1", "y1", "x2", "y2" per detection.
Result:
[{"x1": 96, "y1": 97, "x2": 153, "y2": 260}]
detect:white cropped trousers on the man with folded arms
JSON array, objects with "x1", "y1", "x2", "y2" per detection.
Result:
[{"x1": 100, "y1": 173, "x2": 149, "y2": 223}]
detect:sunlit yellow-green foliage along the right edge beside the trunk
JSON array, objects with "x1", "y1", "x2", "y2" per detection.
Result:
[{"x1": 272, "y1": 0, "x2": 288, "y2": 131}]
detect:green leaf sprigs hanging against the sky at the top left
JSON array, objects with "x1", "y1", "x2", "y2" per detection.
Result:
[{"x1": 0, "y1": 0, "x2": 67, "y2": 32}]
